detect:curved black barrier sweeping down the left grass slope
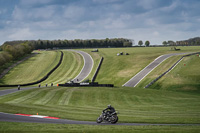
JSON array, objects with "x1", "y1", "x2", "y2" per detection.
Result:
[{"x1": 0, "y1": 51, "x2": 63, "y2": 87}]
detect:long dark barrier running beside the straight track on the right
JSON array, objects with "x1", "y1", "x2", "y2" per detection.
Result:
[{"x1": 144, "y1": 52, "x2": 200, "y2": 88}]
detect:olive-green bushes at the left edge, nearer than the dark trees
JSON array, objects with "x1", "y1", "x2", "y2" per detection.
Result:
[{"x1": 0, "y1": 42, "x2": 33, "y2": 66}]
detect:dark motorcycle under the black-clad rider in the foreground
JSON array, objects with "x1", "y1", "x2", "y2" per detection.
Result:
[{"x1": 96, "y1": 111, "x2": 119, "y2": 124}]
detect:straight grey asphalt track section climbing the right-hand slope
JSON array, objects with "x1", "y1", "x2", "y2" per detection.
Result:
[{"x1": 123, "y1": 53, "x2": 191, "y2": 87}]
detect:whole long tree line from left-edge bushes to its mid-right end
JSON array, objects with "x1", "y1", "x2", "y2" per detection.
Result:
[{"x1": 0, "y1": 38, "x2": 132, "y2": 66}]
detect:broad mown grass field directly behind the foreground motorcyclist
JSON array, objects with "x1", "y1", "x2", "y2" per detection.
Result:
[{"x1": 0, "y1": 87, "x2": 200, "y2": 123}]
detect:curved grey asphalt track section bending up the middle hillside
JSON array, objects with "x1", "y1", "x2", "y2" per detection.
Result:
[{"x1": 70, "y1": 50, "x2": 94, "y2": 83}]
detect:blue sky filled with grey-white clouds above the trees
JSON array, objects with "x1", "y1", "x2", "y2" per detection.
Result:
[{"x1": 0, "y1": 0, "x2": 200, "y2": 45}]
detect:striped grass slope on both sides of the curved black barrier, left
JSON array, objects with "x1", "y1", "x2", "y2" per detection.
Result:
[{"x1": 0, "y1": 51, "x2": 84, "y2": 85}]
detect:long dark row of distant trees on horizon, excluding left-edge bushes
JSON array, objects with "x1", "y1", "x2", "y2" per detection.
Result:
[{"x1": 4, "y1": 38, "x2": 132, "y2": 49}]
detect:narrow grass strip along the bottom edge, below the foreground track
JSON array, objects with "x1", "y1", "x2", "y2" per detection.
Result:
[{"x1": 0, "y1": 122, "x2": 200, "y2": 133}]
